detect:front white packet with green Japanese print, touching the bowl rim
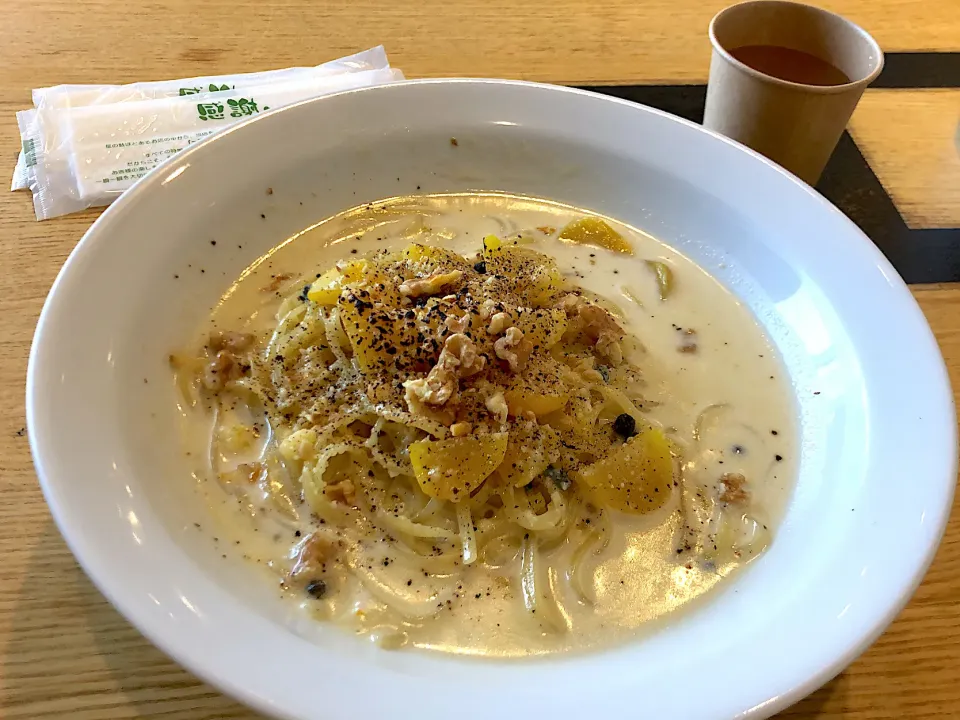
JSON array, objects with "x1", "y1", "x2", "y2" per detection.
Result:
[{"x1": 24, "y1": 68, "x2": 403, "y2": 220}]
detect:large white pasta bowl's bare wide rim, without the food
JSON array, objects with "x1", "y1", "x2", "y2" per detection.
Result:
[{"x1": 27, "y1": 80, "x2": 957, "y2": 720}]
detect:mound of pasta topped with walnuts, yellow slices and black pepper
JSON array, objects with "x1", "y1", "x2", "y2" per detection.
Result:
[{"x1": 171, "y1": 194, "x2": 796, "y2": 654}]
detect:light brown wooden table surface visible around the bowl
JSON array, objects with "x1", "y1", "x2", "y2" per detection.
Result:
[{"x1": 0, "y1": 0, "x2": 960, "y2": 720}]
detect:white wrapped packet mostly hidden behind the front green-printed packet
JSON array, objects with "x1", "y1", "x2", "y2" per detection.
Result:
[{"x1": 10, "y1": 45, "x2": 390, "y2": 190}]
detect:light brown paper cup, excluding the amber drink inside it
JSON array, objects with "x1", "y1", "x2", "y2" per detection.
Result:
[{"x1": 703, "y1": 0, "x2": 883, "y2": 185}]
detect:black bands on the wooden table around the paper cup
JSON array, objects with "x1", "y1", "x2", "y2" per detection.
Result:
[{"x1": 583, "y1": 53, "x2": 960, "y2": 283}]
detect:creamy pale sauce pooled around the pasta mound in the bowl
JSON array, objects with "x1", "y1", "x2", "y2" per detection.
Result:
[{"x1": 174, "y1": 194, "x2": 796, "y2": 656}]
